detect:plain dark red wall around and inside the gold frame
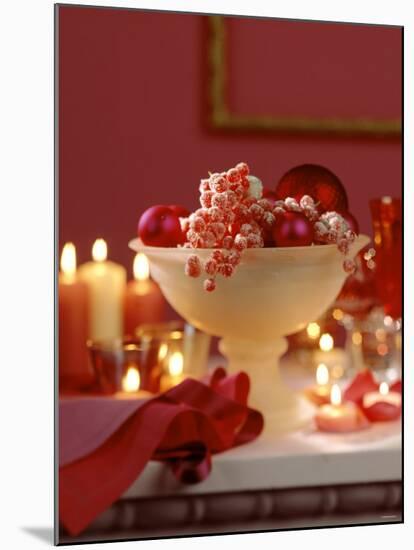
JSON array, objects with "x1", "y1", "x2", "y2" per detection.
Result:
[{"x1": 59, "y1": 7, "x2": 401, "y2": 276}]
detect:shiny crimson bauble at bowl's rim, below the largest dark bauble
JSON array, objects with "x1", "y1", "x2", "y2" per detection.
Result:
[{"x1": 272, "y1": 212, "x2": 313, "y2": 246}]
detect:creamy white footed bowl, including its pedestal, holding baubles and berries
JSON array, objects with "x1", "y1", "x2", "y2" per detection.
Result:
[{"x1": 129, "y1": 235, "x2": 370, "y2": 433}]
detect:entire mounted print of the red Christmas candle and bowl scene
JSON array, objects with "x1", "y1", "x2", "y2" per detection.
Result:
[{"x1": 55, "y1": 5, "x2": 403, "y2": 544}]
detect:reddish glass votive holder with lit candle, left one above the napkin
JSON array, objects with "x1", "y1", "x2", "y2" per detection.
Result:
[{"x1": 88, "y1": 339, "x2": 162, "y2": 396}]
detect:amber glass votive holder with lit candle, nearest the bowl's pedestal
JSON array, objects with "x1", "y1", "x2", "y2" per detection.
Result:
[{"x1": 136, "y1": 321, "x2": 211, "y2": 385}]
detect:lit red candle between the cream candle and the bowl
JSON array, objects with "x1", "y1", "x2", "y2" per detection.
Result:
[{"x1": 124, "y1": 252, "x2": 165, "y2": 337}]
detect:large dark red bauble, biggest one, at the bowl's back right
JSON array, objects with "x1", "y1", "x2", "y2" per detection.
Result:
[{"x1": 276, "y1": 164, "x2": 348, "y2": 213}]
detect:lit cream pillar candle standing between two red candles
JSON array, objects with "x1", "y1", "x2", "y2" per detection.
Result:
[{"x1": 79, "y1": 239, "x2": 126, "y2": 340}]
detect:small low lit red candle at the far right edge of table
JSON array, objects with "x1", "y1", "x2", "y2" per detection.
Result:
[{"x1": 362, "y1": 382, "x2": 401, "y2": 422}]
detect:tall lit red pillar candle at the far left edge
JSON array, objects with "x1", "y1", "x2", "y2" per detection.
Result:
[{"x1": 59, "y1": 243, "x2": 94, "y2": 392}]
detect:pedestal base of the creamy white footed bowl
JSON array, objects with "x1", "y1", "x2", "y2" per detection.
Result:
[{"x1": 219, "y1": 338, "x2": 315, "y2": 436}]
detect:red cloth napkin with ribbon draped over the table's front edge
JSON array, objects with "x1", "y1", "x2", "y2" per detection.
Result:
[{"x1": 59, "y1": 368, "x2": 263, "y2": 535}]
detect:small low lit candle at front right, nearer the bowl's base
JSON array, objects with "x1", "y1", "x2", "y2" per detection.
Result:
[{"x1": 315, "y1": 384, "x2": 368, "y2": 432}]
